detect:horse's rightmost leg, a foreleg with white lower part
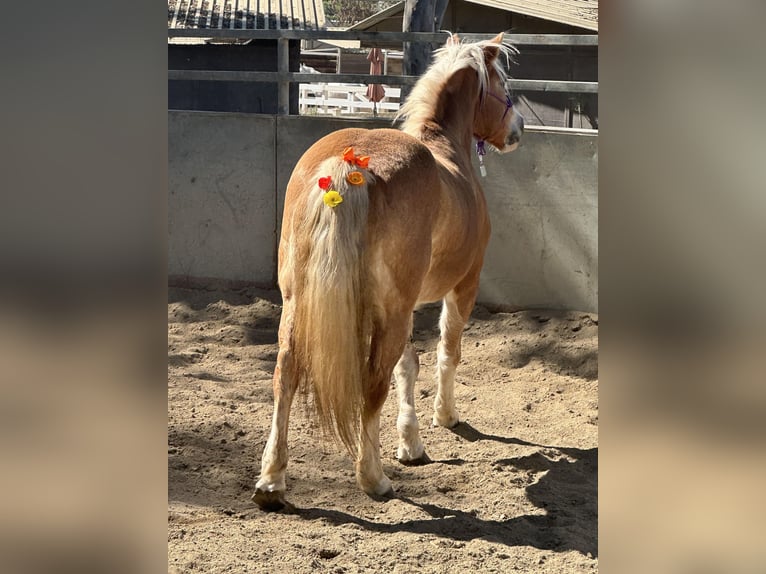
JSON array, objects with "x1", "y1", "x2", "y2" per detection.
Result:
[{"x1": 433, "y1": 278, "x2": 478, "y2": 428}]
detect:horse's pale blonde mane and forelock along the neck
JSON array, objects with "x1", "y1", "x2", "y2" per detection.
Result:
[{"x1": 396, "y1": 36, "x2": 518, "y2": 137}]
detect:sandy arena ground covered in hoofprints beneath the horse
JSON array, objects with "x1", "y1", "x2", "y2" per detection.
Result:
[{"x1": 168, "y1": 288, "x2": 598, "y2": 574}]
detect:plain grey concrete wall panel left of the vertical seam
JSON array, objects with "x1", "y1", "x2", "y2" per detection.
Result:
[{"x1": 168, "y1": 112, "x2": 277, "y2": 284}]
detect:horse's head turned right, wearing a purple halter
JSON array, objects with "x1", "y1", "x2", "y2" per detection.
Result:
[{"x1": 473, "y1": 32, "x2": 524, "y2": 153}]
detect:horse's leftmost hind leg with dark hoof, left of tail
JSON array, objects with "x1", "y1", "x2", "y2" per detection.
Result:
[{"x1": 253, "y1": 300, "x2": 298, "y2": 511}]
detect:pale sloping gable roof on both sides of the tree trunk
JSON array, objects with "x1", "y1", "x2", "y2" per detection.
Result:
[{"x1": 349, "y1": 0, "x2": 598, "y2": 31}]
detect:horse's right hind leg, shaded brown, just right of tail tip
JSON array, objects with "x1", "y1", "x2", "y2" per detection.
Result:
[{"x1": 356, "y1": 313, "x2": 411, "y2": 496}]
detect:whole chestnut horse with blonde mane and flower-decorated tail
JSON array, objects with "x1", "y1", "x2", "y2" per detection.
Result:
[{"x1": 253, "y1": 34, "x2": 523, "y2": 511}]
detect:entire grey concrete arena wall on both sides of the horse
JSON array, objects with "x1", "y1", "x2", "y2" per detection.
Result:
[{"x1": 168, "y1": 111, "x2": 598, "y2": 311}]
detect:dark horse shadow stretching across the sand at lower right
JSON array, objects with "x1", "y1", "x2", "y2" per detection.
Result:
[{"x1": 290, "y1": 423, "x2": 598, "y2": 557}]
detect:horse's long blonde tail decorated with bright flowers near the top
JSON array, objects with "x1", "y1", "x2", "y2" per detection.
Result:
[{"x1": 294, "y1": 158, "x2": 372, "y2": 454}]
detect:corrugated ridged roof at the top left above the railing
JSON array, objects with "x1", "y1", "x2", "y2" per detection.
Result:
[{"x1": 168, "y1": 0, "x2": 325, "y2": 30}]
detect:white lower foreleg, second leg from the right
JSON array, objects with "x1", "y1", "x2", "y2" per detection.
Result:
[{"x1": 394, "y1": 344, "x2": 424, "y2": 462}]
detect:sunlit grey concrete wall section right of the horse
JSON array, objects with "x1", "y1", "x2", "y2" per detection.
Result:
[{"x1": 479, "y1": 130, "x2": 598, "y2": 312}]
